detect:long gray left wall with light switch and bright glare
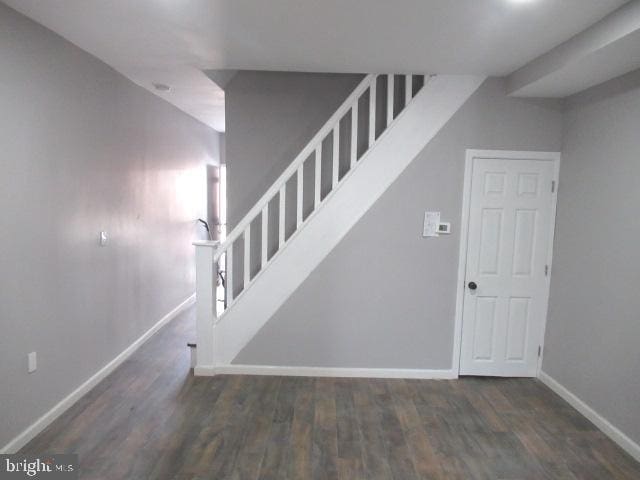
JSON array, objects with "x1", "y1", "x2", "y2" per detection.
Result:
[{"x1": 0, "y1": 4, "x2": 218, "y2": 447}]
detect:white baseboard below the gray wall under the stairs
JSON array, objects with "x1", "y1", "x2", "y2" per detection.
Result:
[{"x1": 194, "y1": 365, "x2": 458, "y2": 379}]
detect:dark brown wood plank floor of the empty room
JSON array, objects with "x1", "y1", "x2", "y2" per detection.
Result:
[{"x1": 22, "y1": 310, "x2": 640, "y2": 480}]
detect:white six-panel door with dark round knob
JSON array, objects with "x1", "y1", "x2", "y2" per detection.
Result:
[{"x1": 460, "y1": 155, "x2": 556, "y2": 377}]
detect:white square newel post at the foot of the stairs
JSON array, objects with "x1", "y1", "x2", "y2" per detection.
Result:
[{"x1": 194, "y1": 242, "x2": 219, "y2": 375}]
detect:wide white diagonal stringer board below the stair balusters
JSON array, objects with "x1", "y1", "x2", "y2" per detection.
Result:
[{"x1": 195, "y1": 75, "x2": 485, "y2": 375}]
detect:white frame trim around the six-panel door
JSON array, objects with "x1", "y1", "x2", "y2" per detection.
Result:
[{"x1": 451, "y1": 149, "x2": 561, "y2": 375}]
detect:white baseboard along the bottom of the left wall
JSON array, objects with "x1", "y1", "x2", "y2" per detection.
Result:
[{"x1": 0, "y1": 294, "x2": 196, "y2": 453}]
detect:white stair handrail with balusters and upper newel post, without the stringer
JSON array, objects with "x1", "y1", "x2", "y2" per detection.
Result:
[{"x1": 194, "y1": 74, "x2": 427, "y2": 328}]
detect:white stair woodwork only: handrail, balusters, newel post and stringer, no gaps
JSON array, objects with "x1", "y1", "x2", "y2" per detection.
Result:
[{"x1": 195, "y1": 75, "x2": 484, "y2": 375}]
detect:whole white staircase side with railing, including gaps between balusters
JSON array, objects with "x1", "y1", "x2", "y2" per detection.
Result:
[{"x1": 194, "y1": 75, "x2": 484, "y2": 375}]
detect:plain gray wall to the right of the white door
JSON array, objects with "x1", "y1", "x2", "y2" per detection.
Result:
[{"x1": 543, "y1": 71, "x2": 640, "y2": 442}]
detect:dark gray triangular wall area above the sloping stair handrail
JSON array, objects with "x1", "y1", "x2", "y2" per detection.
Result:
[{"x1": 225, "y1": 71, "x2": 363, "y2": 231}]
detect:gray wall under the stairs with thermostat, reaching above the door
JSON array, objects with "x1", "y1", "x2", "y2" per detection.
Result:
[{"x1": 234, "y1": 79, "x2": 562, "y2": 369}]
